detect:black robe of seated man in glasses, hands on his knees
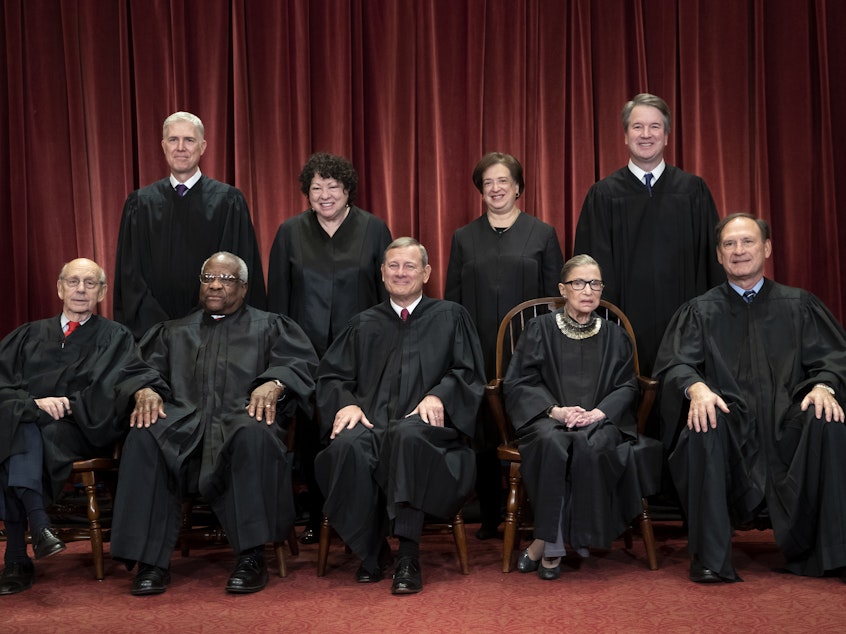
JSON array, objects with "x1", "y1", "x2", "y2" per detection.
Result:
[{"x1": 111, "y1": 305, "x2": 317, "y2": 566}]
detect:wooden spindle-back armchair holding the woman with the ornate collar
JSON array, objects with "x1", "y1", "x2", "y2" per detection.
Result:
[{"x1": 485, "y1": 297, "x2": 661, "y2": 572}]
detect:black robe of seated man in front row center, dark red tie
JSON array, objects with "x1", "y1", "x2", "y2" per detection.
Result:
[{"x1": 315, "y1": 296, "x2": 485, "y2": 557}]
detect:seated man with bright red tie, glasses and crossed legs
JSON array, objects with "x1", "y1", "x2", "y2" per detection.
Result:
[{"x1": 0, "y1": 258, "x2": 137, "y2": 595}]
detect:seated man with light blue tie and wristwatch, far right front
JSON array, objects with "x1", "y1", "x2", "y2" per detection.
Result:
[{"x1": 656, "y1": 214, "x2": 846, "y2": 583}]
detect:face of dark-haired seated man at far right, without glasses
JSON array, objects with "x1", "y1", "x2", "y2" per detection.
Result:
[{"x1": 717, "y1": 218, "x2": 772, "y2": 290}]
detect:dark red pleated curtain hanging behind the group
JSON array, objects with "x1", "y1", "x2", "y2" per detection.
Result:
[{"x1": 0, "y1": 0, "x2": 846, "y2": 335}]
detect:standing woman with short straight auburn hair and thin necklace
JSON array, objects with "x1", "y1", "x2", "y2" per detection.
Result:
[{"x1": 444, "y1": 152, "x2": 564, "y2": 539}]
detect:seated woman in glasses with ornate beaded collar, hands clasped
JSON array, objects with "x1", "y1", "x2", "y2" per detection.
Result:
[{"x1": 504, "y1": 255, "x2": 641, "y2": 580}]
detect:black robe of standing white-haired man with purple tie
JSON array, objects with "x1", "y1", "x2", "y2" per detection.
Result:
[{"x1": 113, "y1": 175, "x2": 266, "y2": 339}]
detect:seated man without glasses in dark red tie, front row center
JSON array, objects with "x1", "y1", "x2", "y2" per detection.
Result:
[{"x1": 315, "y1": 238, "x2": 485, "y2": 594}]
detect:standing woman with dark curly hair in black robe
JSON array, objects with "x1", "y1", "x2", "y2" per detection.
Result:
[{"x1": 268, "y1": 152, "x2": 391, "y2": 543}]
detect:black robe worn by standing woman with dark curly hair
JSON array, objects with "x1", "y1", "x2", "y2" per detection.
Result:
[{"x1": 267, "y1": 206, "x2": 391, "y2": 357}]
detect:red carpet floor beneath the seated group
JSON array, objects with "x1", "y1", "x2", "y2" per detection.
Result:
[{"x1": 0, "y1": 523, "x2": 846, "y2": 634}]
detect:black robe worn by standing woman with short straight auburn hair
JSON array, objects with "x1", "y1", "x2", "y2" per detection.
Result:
[{"x1": 444, "y1": 213, "x2": 564, "y2": 381}]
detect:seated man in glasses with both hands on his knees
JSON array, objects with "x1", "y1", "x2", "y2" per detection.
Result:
[{"x1": 111, "y1": 252, "x2": 317, "y2": 595}]
